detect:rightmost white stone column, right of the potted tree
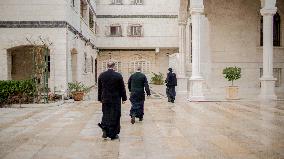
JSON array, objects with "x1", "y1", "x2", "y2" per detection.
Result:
[{"x1": 259, "y1": 8, "x2": 277, "y2": 100}]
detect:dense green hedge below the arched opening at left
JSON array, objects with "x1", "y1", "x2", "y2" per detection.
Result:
[{"x1": 0, "y1": 80, "x2": 35, "y2": 105}]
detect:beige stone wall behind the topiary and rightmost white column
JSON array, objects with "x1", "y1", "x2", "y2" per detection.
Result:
[{"x1": 204, "y1": 0, "x2": 284, "y2": 94}]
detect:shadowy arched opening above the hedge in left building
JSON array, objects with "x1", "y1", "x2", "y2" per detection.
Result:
[{"x1": 7, "y1": 45, "x2": 50, "y2": 82}]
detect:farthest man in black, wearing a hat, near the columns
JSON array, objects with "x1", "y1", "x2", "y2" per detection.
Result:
[{"x1": 165, "y1": 68, "x2": 177, "y2": 103}]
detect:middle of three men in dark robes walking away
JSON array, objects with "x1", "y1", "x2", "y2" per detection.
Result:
[{"x1": 128, "y1": 66, "x2": 151, "y2": 124}]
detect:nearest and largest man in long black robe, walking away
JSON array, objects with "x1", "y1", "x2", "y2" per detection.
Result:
[{"x1": 98, "y1": 62, "x2": 127, "y2": 140}]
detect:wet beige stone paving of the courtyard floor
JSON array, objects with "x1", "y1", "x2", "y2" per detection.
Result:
[{"x1": 0, "y1": 98, "x2": 284, "y2": 159}]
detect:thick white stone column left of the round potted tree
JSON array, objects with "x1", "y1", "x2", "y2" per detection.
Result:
[{"x1": 189, "y1": 5, "x2": 204, "y2": 101}]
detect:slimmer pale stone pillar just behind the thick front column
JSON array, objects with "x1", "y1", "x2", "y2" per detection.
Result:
[{"x1": 177, "y1": 22, "x2": 188, "y2": 94}]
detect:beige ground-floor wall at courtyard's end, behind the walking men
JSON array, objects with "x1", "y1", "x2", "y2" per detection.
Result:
[{"x1": 98, "y1": 49, "x2": 177, "y2": 82}]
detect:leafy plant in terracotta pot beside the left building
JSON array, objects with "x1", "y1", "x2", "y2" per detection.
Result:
[{"x1": 68, "y1": 81, "x2": 93, "y2": 101}]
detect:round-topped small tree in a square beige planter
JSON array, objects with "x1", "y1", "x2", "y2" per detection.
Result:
[{"x1": 223, "y1": 66, "x2": 241, "y2": 99}]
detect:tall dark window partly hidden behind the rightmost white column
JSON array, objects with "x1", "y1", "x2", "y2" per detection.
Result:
[{"x1": 260, "y1": 13, "x2": 281, "y2": 46}]
